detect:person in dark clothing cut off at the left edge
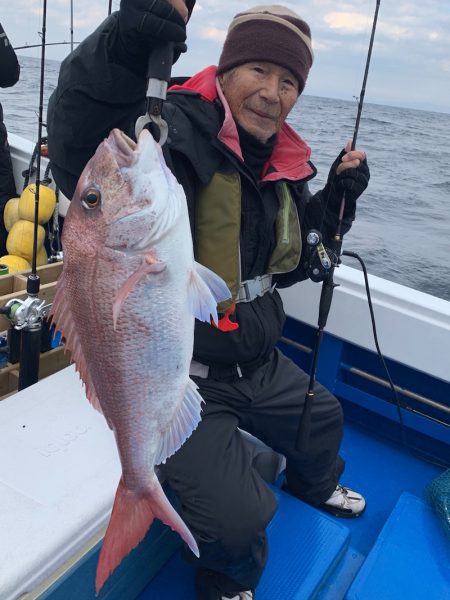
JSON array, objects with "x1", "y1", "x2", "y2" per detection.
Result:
[{"x1": 0, "y1": 23, "x2": 20, "y2": 254}]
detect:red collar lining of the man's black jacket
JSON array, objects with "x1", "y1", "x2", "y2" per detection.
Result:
[{"x1": 170, "y1": 66, "x2": 314, "y2": 181}]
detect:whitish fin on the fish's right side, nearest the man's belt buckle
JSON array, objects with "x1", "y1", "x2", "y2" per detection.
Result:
[{"x1": 188, "y1": 262, "x2": 231, "y2": 323}]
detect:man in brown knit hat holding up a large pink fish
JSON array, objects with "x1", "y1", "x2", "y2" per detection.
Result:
[{"x1": 47, "y1": 0, "x2": 369, "y2": 600}]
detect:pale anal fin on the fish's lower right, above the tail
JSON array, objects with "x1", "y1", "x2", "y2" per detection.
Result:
[{"x1": 155, "y1": 379, "x2": 203, "y2": 465}]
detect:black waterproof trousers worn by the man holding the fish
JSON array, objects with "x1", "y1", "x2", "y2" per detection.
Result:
[{"x1": 162, "y1": 350, "x2": 344, "y2": 600}]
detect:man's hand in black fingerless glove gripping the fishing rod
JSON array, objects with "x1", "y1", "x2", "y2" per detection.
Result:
[{"x1": 328, "y1": 142, "x2": 370, "y2": 201}]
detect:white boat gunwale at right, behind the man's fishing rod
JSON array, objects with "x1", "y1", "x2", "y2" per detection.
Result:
[{"x1": 281, "y1": 265, "x2": 450, "y2": 381}]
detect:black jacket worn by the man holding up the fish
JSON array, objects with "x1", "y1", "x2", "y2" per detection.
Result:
[{"x1": 47, "y1": 15, "x2": 355, "y2": 370}]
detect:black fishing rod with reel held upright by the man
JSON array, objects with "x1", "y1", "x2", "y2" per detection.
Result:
[{"x1": 296, "y1": 0, "x2": 381, "y2": 452}]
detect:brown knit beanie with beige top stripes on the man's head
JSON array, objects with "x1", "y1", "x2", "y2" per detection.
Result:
[{"x1": 217, "y1": 4, "x2": 314, "y2": 93}]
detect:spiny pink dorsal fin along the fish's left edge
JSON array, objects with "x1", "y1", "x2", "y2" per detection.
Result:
[{"x1": 49, "y1": 273, "x2": 103, "y2": 414}]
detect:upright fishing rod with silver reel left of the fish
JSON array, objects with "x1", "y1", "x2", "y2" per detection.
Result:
[{"x1": 2, "y1": 0, "x2": 50, "y2": 391}]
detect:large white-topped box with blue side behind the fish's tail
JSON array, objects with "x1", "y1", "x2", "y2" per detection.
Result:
[{"x1": 0, "y1": 366, "x2": 180, "y2": 600}]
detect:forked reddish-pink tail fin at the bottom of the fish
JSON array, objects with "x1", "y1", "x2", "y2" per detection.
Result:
[{"x1": 95, "y1": 477, "x2": 199, "y2": 594}]
